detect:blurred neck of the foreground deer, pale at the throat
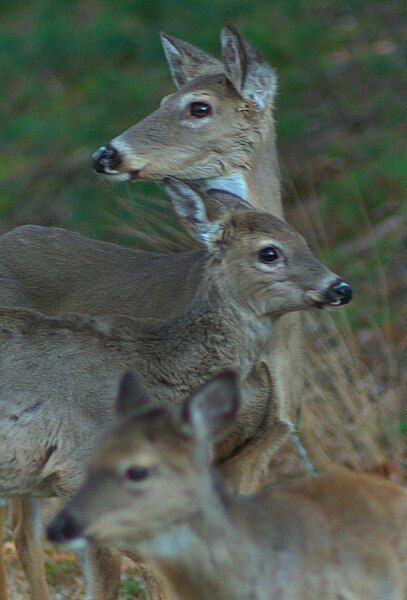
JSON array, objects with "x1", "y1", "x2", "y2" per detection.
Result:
[{"x1": 141, "y1": 482, "x2": 253, "y2": 600}]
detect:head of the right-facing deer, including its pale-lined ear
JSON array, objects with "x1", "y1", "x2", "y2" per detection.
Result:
[{"x1": 165, "y1": 177, "x2": 352, "y2": 317}]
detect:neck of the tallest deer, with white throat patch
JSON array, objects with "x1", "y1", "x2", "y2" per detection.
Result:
[{"x1": 197, "y1": 111, "x2": 283, "y2": 217}]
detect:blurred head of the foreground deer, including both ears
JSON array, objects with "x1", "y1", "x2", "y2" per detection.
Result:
[{"x1": 48, "y1": 372, "x2": 238, "y2": 548}]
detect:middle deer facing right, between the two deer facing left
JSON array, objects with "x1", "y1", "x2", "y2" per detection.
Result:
[{"x1": 0, "y1": 178, "x2": 351, "y2": 600}]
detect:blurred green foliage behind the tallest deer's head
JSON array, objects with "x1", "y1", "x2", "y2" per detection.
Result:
[{"x1": 0, "y1": 0, "x2": 407, "y2": 258}]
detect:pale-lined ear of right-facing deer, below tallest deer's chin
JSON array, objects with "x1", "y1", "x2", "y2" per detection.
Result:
[{"x1": 164, "y1": 177, "x2": 220, "y2": 247}]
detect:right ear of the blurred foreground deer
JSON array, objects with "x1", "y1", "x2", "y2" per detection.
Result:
[{"x1": 183, "y1": 371, "x2": 239, "y2": 443}]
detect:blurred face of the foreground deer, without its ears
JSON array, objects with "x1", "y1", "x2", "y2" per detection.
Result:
[{"x1": 45, "y1": 410, "x2": 196, "y2": 548}]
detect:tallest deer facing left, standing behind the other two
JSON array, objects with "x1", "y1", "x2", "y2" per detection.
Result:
[{"x1": 0, "y1": 31, "x2": 310, "y2": 592}]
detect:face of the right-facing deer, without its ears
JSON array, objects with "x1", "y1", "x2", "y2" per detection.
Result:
[{"x1": 214, "y1": 211, "x2": 351, "y2": 316}]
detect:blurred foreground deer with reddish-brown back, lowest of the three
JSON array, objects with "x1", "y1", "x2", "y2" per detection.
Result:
[{"x1": 48, "y1": 373, "x2": 407, "y2": 600}]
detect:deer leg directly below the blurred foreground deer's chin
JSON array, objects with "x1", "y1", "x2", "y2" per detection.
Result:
[{"x1": 83, "y1": 544, "x2": 121, "y2": 600}]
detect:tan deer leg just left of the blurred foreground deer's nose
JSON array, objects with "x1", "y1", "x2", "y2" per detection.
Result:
[{"x1": 11, "y1": 496, "x2": 49, "y2": 600}]
